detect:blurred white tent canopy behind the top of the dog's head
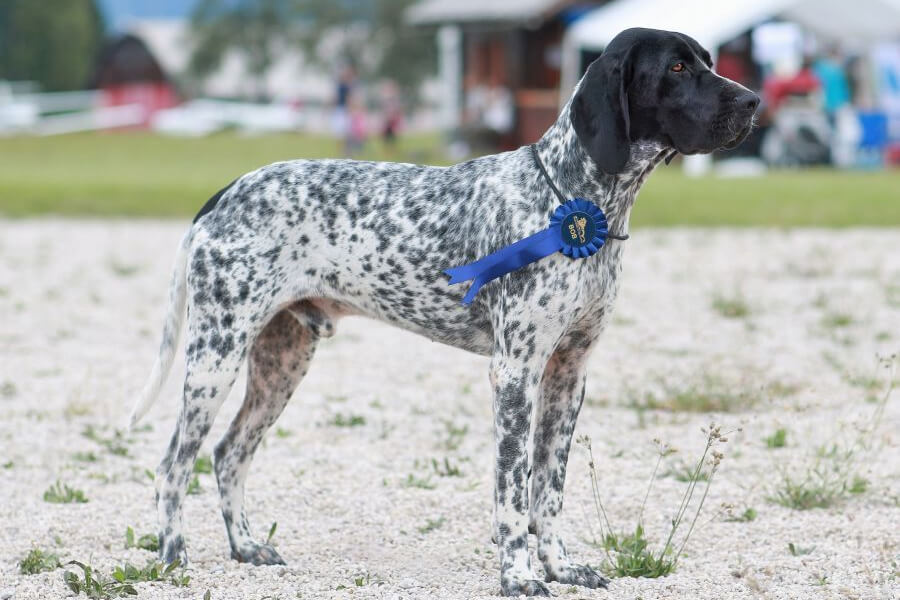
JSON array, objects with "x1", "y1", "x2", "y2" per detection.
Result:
[{"x1": 561, "y1": 0, "x2": 900, "y2": 95}]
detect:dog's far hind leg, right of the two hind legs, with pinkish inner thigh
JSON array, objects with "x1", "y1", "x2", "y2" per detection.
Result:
[{"x1": 214, "y1": 303, "x2": 322, "y2": 565}]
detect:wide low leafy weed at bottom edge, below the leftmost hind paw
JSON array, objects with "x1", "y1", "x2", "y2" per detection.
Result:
[{"x1": 63, "y1": 560, "x2": 191, "y2": 600}]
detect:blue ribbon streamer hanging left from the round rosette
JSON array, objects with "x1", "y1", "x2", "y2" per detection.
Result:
[{"x1": 444, "y1": 226, "x2": 562, "y2": 305}]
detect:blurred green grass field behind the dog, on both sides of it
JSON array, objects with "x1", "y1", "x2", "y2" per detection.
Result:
[{"x1": 0, "y1": 133, "x2": 900, "y2": 227}]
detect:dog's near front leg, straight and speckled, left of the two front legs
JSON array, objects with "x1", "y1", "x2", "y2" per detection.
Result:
[{"x1": 491, "y1": 356, "x2": 550, "y2": 596}]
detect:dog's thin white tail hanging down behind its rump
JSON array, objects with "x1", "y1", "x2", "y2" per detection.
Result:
[{"x1": 128, "y1": 231, "x2": 192, "y2": 429}]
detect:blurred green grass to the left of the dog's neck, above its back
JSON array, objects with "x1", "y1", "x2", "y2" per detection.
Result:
[{"x1": 0, "y1": 133, "x2": 446, "y2": 217}]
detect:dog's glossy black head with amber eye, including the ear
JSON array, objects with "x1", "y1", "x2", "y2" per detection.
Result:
[{"x1": 571, "y1": 28, "x2": 759, "y2": 173}]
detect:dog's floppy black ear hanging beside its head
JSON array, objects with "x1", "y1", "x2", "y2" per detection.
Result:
[{"x1": 570, "y1": 53, "x2": 631, "y2": 174}]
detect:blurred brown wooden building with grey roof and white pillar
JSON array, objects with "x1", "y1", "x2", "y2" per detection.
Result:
[{"x1": 407, "y1": 0, "x2": 604, "y2": 148}]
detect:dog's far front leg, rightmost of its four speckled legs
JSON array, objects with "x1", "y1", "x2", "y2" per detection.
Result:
[{"x1": 531, "y1": 347, "x2": 609, "y2": 588}]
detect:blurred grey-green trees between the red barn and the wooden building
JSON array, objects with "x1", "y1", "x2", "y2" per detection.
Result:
[{"x1": 190, "y1": 0, "x2": 436, "y2": 99}]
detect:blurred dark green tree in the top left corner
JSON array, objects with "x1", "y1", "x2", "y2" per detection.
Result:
[{"x1": 0, "y1": 0, "x2": 103, "y2": 91}]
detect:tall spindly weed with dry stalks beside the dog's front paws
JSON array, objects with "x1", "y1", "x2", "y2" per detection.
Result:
[{"x1": 577, "y1": 423, "x2": 739, "y2": 578}]
